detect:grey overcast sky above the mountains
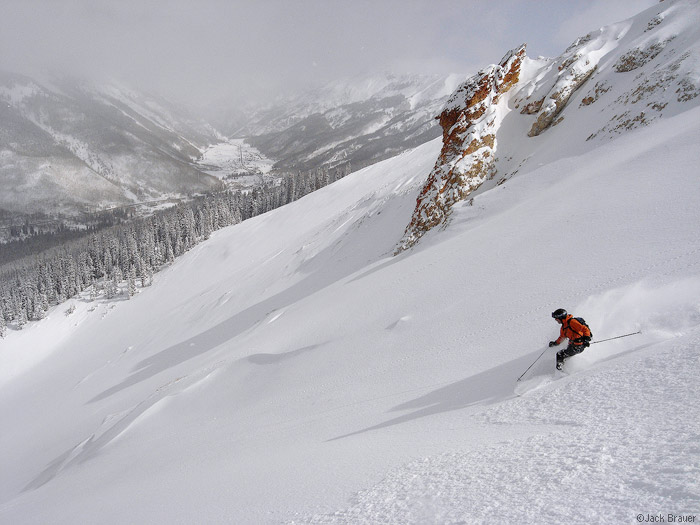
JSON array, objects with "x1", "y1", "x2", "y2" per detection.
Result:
[{"x1": 0, "y1": 0, "x2": 656, "y2": 103}]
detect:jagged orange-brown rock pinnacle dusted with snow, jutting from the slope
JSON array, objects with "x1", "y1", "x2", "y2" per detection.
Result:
[{"x1": 397, "y1": 44, "x2": 525, "y2": 253}]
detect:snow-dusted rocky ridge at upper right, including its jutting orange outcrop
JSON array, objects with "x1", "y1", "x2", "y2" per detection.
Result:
[{"x1": 400, "y1": 3, "x2": 700, "y2": 249}]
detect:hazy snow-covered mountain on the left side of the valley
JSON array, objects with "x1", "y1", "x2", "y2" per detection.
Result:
[{"x1": 0, "y1": 73, "x2": 220, "y2": 213}]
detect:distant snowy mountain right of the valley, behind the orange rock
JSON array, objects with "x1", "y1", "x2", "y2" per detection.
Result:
[{"x1": 217, "y1": 75, "x2": 461, "y2": 170}]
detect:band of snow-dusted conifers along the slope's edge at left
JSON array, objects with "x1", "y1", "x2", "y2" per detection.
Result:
[{"x1": 0, "y1": 164, "x2": 350, "y2": 337}]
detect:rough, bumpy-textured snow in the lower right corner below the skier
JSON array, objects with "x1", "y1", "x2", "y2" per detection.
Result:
[{"x1": 298, "y1": 336, "x2": 700, "y2": 524}]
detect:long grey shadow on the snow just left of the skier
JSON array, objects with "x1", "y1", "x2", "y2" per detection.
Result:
[{"x1": 328, "y1": 354, "x2": 540, "y2": 441}]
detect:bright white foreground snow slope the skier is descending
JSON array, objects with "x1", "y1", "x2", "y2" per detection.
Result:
[{"x1": 0, "y1": 0, "x2": 700, "y2": 524}]
